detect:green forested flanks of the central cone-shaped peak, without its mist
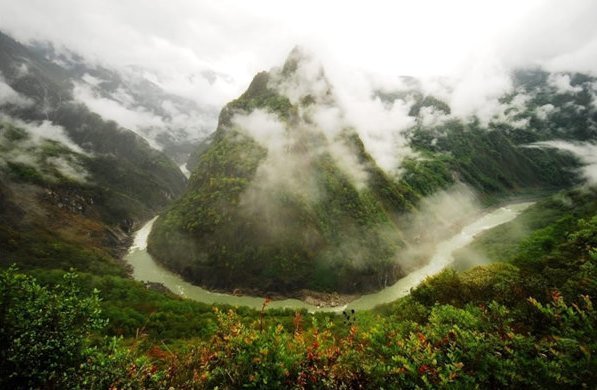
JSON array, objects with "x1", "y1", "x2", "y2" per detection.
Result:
[{"x1": 149, "y1": 59, "x2": 412, "y2": 293}]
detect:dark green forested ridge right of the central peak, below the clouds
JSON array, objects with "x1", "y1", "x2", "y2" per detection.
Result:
[{"x1": 407, "y1": 120, "x2": 578, "y2": 196}]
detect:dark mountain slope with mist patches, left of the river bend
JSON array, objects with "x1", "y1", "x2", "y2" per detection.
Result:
[{"x1": 0, "y1": 34, "x2": 186, "y2": 274}]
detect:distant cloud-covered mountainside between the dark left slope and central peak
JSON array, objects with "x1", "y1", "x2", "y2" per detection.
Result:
[{"x1": 28, "y1": 42, "x2": 217, "y2": 165}]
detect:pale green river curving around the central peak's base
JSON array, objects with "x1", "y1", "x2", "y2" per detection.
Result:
[{"x1": 125, "y1": 202, "x2": 533, "y2": 312}]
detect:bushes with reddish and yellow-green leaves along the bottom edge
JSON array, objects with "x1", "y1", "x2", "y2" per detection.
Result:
[{"x1": 121, "y1": 296, "x2": 597, "y2": 389}]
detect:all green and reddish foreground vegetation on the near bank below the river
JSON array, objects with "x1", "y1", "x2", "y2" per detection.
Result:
[{"x1": 0, "y1": 188, "x2": 597, "y2": 389}]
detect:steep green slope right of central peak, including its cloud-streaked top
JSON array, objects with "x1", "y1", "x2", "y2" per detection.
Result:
[{"x1": 380, "y1": 69, "x2": 597, "y2": 196}]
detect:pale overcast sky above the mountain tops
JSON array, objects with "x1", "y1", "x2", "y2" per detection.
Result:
[{"x1": 0, "y1": 0, "x2": 597, "y2": 109}]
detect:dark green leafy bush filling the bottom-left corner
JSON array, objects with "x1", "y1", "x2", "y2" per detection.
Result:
[{"x1": 0, "y1": 268, "x2": 104, "y2": 388}]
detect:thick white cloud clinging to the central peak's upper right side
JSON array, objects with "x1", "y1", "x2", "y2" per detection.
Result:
[{"x1": 270, "y1": 50, "x2": 415, "y2": 174}]
